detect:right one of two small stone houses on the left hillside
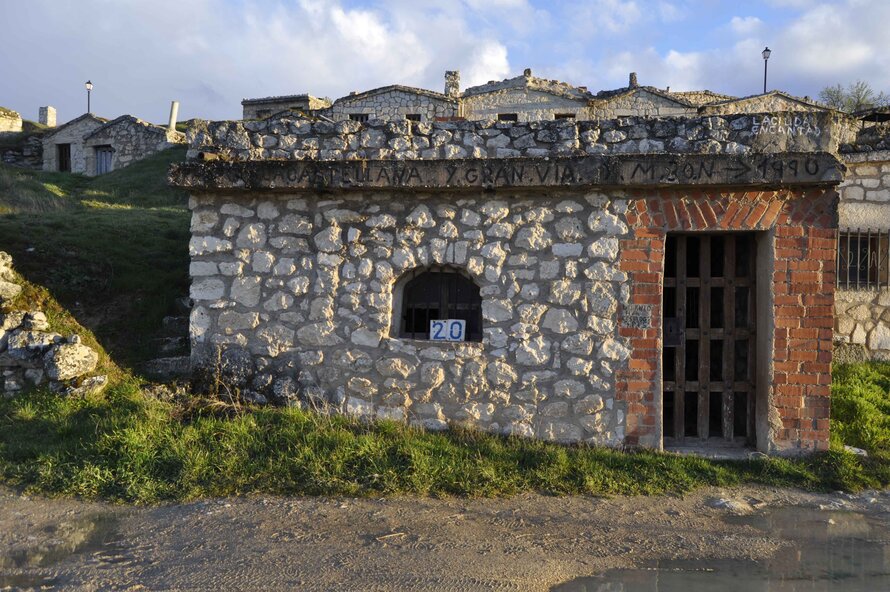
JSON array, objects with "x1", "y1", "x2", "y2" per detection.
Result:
[{"x1": 83, "y1": 115, "x2": 185, "y2": 175}]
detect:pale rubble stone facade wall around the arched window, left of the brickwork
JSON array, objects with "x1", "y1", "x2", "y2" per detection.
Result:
[{"x1": 190, "y1": 190, "x2": 629, "y2": 445}]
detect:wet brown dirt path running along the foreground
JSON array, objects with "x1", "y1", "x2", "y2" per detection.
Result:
[{"x1": 0, "y1": 488, "x2": 890, "y2": 592}]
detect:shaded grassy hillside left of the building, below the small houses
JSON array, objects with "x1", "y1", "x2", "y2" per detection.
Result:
[{"x1": 0, "y1": 148, "x2": 189, "y2": 368}]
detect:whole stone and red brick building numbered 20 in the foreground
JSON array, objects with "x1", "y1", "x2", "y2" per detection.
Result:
[{"x1": 171, "y1": 114, "x2": 842, "y2": 454}]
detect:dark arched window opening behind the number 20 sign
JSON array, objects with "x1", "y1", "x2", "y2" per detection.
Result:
[{"x1": 397, "y1": 267, "x2": 482, "y2": 341}]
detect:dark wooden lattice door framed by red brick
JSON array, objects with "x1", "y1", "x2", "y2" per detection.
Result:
[{"x1": 662, "y1": 233, "x2": 756, "y2": 447}]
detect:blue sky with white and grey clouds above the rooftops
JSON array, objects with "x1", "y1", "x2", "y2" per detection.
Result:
[{"x1": 0, "y1": 0, "x2": 890, "y2": 123}]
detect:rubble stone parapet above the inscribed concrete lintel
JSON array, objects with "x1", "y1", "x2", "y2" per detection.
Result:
[{"x1": 187, "y1": 113, "x2": 847, "y2": 162}]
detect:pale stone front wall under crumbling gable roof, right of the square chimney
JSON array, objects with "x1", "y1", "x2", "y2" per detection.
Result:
[{"x1": 461, "y1": 88, "x2": 590, "y2": 121}]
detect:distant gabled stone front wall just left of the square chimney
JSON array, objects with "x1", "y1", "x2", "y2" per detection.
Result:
[{"x1": 321, "y1": 89, "x2": 458, "y2": 122}]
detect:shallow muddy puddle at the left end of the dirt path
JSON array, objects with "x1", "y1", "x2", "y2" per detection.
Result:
[{"x1": 0, "y1": 514, "x2": 131, "y2": 590}]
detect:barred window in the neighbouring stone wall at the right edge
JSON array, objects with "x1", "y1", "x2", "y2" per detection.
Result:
[{"x1": 837, "y1": 228, "x2": 890, "y2": 290}]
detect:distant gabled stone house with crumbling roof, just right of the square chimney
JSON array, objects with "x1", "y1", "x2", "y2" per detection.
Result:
[{"x1": 461, "y1": 70, "x2": 593, "y2": 122}]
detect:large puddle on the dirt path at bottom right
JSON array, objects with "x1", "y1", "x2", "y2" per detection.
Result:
[{"x1": 552, "y1": 508, "x2": 890, "y2": 592}]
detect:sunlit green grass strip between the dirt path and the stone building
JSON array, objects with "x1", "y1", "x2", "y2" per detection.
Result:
[{"x1": 0, "y1": 356, "x2": 890, "y2": 503}]
